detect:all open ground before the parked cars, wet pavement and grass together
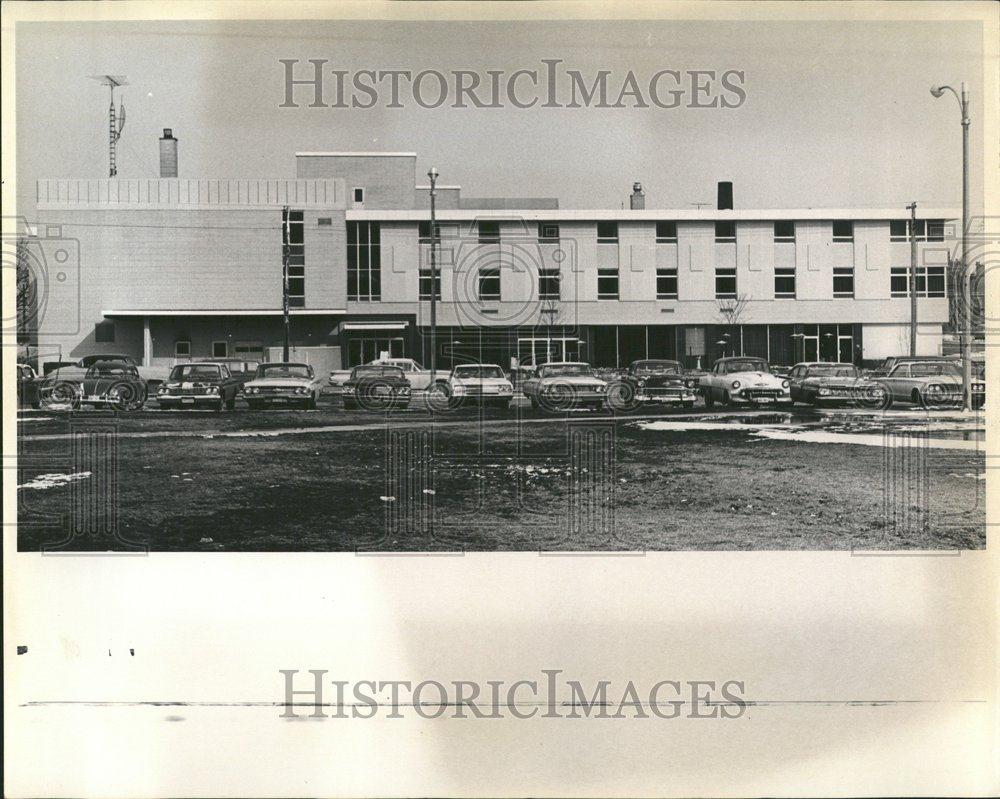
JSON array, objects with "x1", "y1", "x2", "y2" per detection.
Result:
[{"x1": 18, "y1": 393, "x2": 985, "y2": 552}]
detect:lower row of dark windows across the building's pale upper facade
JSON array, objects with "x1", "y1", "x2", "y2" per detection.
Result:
[{"x1": 406, "y1": 266, "x2": 945, "y2": 301}]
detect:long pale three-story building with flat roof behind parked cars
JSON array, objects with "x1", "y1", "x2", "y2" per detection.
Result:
[{"x1": 27, "y1": 145, "x2": 957, "y2": 376}]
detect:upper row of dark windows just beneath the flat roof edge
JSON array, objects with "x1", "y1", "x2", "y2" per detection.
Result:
[{"x1": 414, "y1": 219, "x2": 944, "y2": 244}]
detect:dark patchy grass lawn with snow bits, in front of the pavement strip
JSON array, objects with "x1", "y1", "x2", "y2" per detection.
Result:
[{"x1": 18, "y1": 410, "x2": 985, "y2": 552}]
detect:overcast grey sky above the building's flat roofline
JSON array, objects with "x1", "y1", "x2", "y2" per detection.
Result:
[{"x1": 17, "y1": 21, "x2": 983, "y2": 210}]
